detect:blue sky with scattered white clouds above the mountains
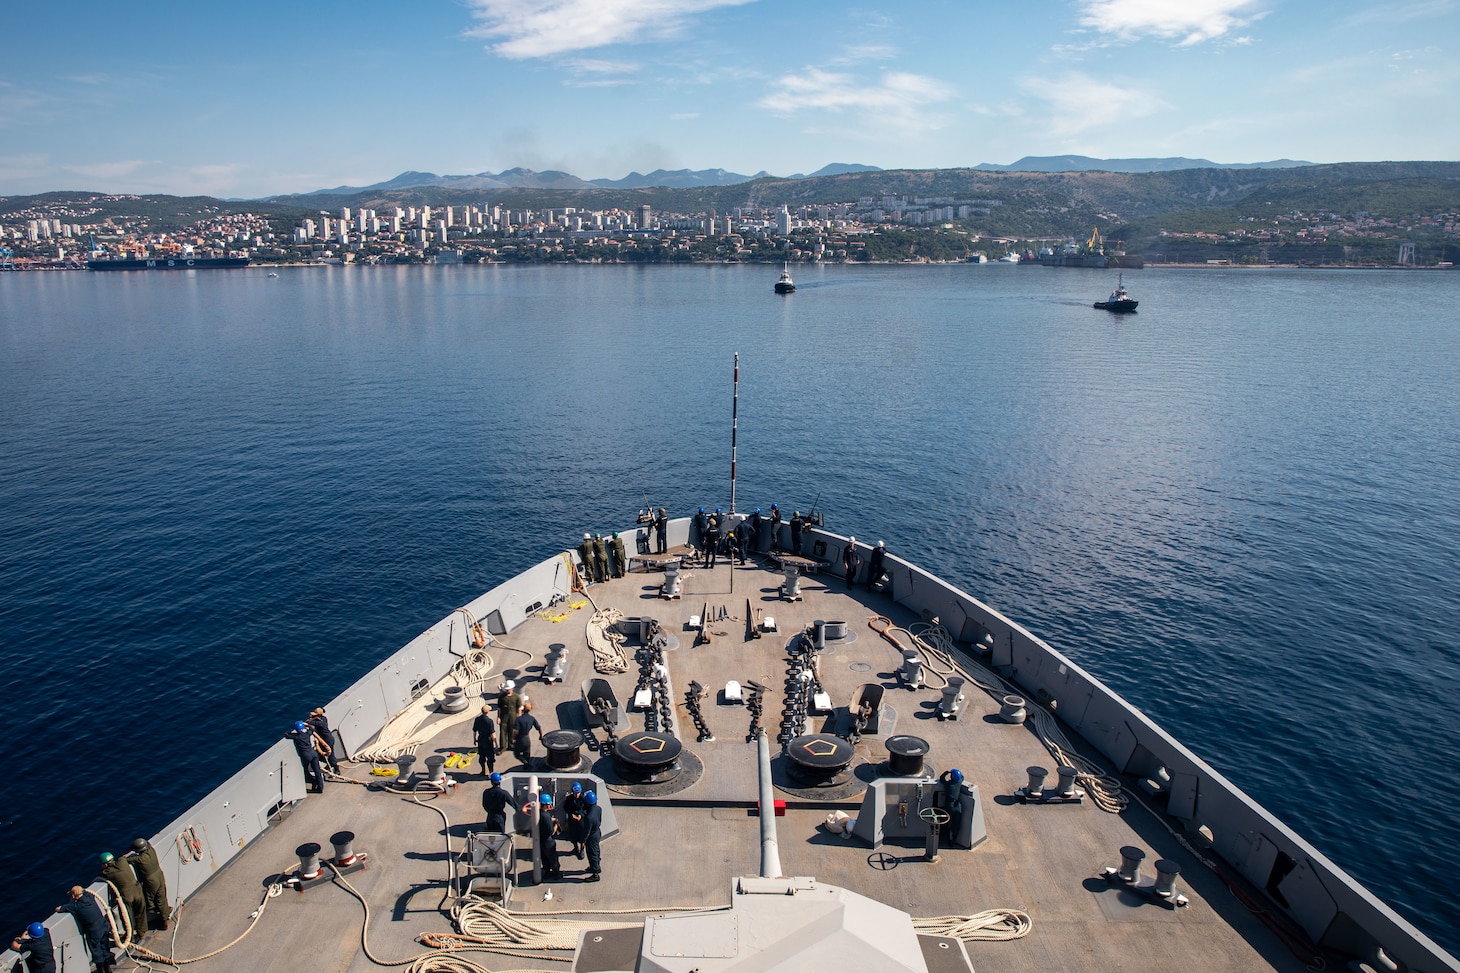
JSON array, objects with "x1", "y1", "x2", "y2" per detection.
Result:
[{"x1": 0, "y1": 0, "x2": 1460, "y2": 197}]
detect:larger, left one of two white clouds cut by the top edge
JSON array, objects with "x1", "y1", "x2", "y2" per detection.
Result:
[{"x1": 467, "y1": 0, "x2": 753, "y2": 60}]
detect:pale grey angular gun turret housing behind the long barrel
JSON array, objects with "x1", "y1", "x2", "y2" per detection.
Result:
[{"x1": 635, "y1": 878, "x2": 929, "y2": 973}]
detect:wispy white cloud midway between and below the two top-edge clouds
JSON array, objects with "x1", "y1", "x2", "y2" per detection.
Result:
[{"x1": 756, "y1": 67, "x2": 953, "y2": 129}]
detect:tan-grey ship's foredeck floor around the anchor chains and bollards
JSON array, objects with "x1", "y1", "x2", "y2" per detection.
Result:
[{"x1": 145, "y1": 562, "x2": 1304, "y2": 973}]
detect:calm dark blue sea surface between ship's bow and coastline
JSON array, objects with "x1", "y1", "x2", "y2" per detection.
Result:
[{"x1": 0, "y1": 266, "x2": 1460, "y2": 951}]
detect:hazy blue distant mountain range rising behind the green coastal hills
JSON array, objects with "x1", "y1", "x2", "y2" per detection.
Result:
[{"x1": 304, "y1": 155, "x2": 1313, "y2": 196}]
